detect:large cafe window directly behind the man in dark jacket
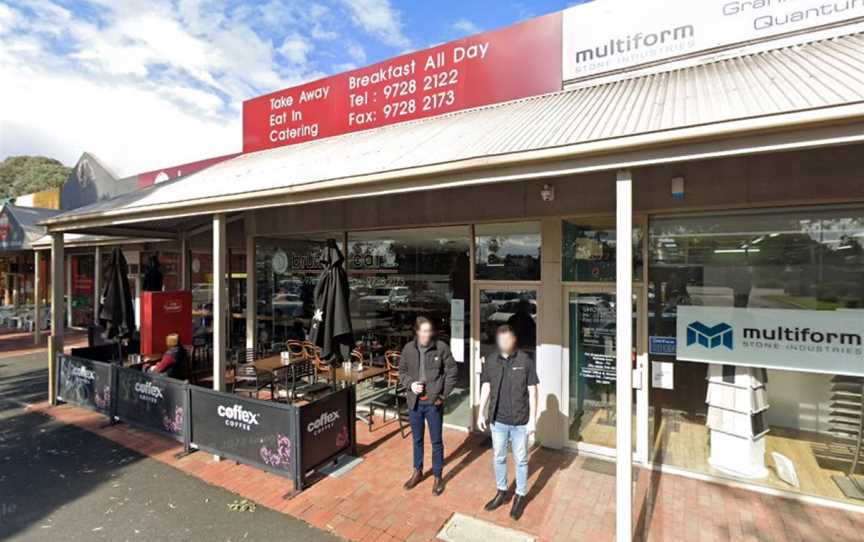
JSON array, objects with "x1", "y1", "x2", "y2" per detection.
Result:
[{"x1": 347, "y1": 227, "x2": 471, "y2": 426}]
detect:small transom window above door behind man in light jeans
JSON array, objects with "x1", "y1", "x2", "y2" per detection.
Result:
[{"x1": 474, "y1": 222, "x2": 541, "y2": 281}]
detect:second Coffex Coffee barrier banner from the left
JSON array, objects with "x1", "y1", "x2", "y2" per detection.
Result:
[{"x1": 114, "y1": 367, "x2": 188, "y2": 440}]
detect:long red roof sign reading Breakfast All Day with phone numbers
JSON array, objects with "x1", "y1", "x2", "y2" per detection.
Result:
[{"x1": 243, "y1": 13, "x2": 562, "y2": 152}]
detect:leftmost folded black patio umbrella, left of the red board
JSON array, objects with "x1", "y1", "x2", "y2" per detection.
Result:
[{"x1": 99, "y1": 248, "x2": 135, "y2": 343}]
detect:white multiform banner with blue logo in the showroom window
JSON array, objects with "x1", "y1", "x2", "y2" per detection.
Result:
[{"x1": 676, "y1": 306, "x2": 864, "y2": 376}]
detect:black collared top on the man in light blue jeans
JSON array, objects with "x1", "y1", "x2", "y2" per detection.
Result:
[{"x1": 480, "y1": 350, "x2": 540, "y2": 425}]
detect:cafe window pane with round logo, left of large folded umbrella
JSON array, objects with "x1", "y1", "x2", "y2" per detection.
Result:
[{"x1": 255, "y1": 237, "x2": 334, "y2": 345}]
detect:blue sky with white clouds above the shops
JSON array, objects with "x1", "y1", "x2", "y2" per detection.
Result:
[{"x1": 0, "y1": 0, "x2": 580, "y2": 177}]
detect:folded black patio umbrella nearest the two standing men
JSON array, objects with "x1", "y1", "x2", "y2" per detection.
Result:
[{"x1": 310, "y1": 239, "x2": 354, "y2": 361}]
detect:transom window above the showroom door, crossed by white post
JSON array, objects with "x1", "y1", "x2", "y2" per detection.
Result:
[{"x1": 561, "y1": 218, "x2": 643, "y2": 282}]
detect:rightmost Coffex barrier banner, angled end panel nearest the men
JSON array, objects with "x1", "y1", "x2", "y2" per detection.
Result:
[{"x1": 299, "y1": 388, "x2": 354, "y2": 473}]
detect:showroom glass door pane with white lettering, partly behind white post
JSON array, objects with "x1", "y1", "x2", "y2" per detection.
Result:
[{"x1": 565, "y1": 286, "x2": 647, "y2": 460}]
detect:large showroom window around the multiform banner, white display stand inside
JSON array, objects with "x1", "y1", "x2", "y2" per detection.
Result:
[{"x1": 649, "y1": 210, "x2": 864, "y2": 504}]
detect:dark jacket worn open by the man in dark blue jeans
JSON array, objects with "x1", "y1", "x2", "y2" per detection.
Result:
[{"x1": 399, "y1": 341, "x2": 459, "y2": 410}]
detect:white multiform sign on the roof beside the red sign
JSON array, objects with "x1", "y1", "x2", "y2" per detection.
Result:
[{"x1": 562, "y1": 0, "x2": 864, "y2": 81}]
